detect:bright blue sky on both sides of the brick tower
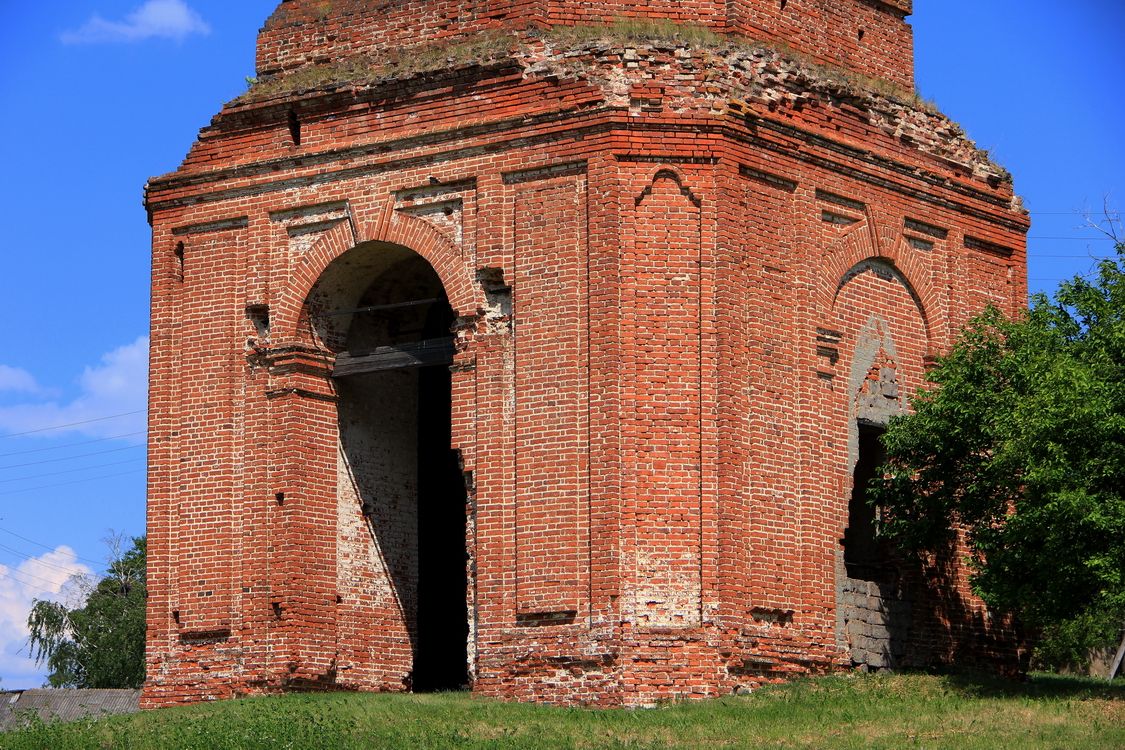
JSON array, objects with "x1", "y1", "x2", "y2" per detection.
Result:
[{"x1": 0, "y1": 0, "x2": 1125, "y2": 688}]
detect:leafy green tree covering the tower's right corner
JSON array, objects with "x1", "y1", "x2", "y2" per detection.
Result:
[{"x1": 872, "y1": 243, "x2": 1125, "y2": 679}]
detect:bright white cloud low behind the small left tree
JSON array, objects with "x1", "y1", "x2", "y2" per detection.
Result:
[{"x1": 0, "y1": 546, "x2": 92, "y2": 689}]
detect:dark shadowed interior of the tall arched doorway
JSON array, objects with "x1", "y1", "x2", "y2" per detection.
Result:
[{"x1": 308, "y1": 243, "x2": 469, "y2": 692}]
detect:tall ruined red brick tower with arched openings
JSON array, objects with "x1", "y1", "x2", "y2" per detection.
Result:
[{"x1": 144, "y1": 0, "x2": 1028, "y2": 706}]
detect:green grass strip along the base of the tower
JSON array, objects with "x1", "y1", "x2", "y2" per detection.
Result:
[{"x1": 0, "y1": 675, "x2": 1125, "y2": 750}]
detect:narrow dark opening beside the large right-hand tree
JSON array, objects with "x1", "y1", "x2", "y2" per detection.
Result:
[{"x1": 844, "y1": 422, "x2": 890, "y2": 581}]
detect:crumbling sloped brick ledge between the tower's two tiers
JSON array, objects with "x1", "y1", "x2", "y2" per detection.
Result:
[{"x1": 156, "y1": 37, "x2": 1014, "y2": 222}]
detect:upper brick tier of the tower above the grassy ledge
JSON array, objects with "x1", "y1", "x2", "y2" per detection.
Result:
[{"x1": 258, "y1": 0, "x2": 914, "y2": 88}]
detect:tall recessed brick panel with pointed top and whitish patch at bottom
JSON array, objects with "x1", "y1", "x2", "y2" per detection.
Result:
[{"x1": 621, "y1": 166, "x2": 703, "y2": 629}]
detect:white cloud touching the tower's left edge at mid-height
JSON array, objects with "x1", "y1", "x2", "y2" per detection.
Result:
[{"x1": 0, "y1": 336, "x2": 149, "y2": 442}]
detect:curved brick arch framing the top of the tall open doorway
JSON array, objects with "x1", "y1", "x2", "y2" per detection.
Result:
[{"x1": 275, "y1": 207, "x2": 485, "y2": 341}]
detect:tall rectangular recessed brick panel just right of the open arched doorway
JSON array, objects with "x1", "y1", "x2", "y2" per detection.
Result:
[{"x1": 512, "y1": 168, "x2": 590, "y2": 617}]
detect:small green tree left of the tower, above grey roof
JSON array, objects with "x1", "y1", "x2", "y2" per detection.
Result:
[{"x1": 27, "y1": 536, "x2": 146, "y2": 688}]
